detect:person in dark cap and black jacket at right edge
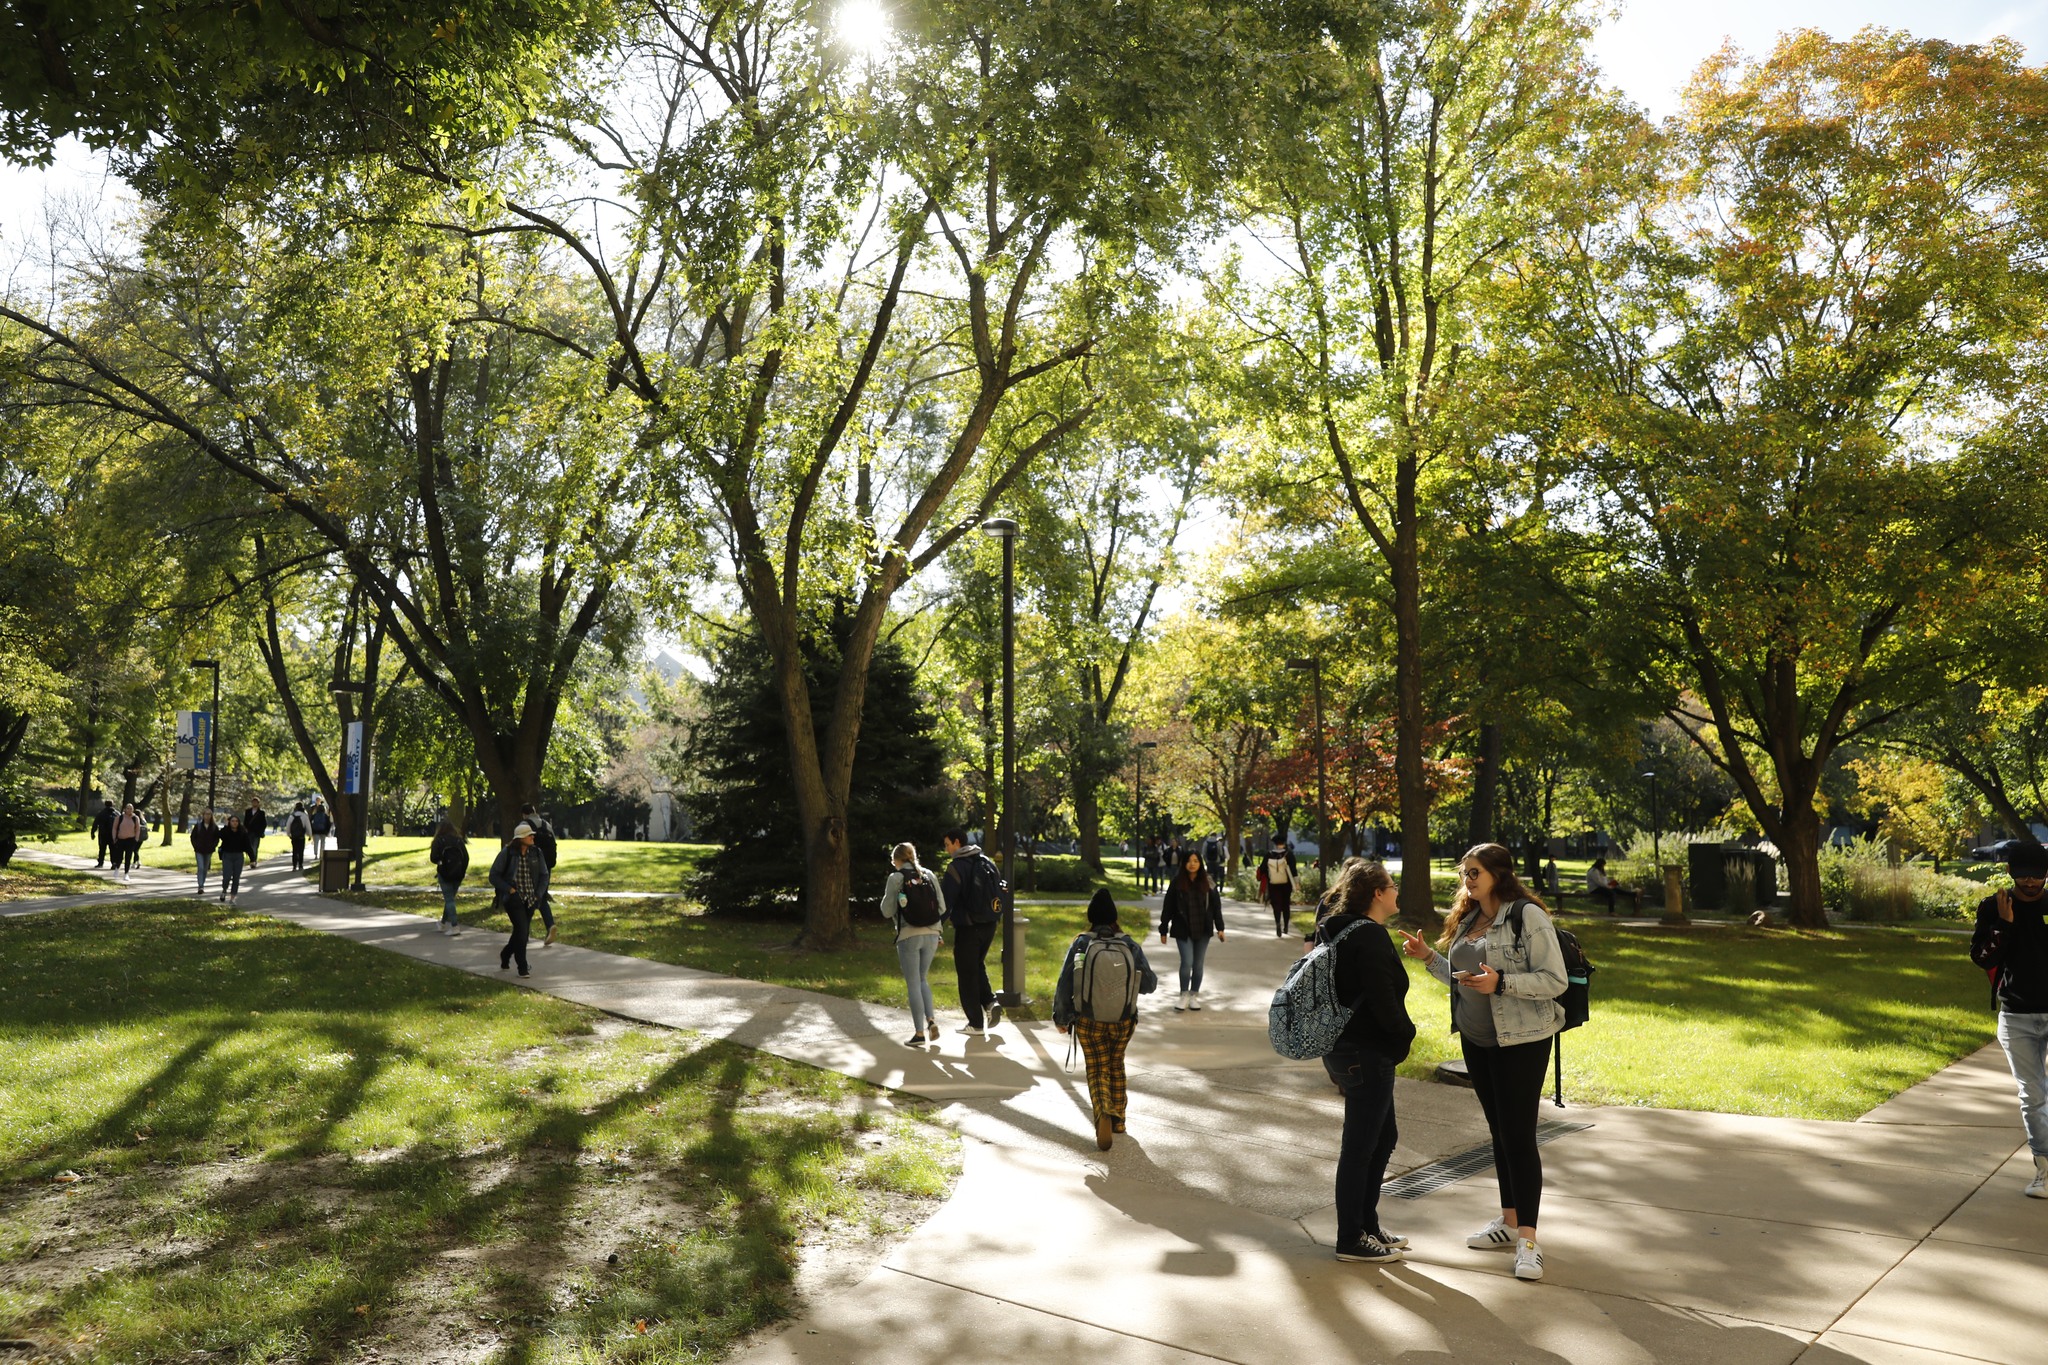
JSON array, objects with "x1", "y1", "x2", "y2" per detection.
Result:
[{"x1": 1970, "y1": 839, "x2": 2048, "y2": 1199}]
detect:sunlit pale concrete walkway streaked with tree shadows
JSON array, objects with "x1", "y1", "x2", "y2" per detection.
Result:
[{"x1": 0, "y1": 849, "x2": 2048, "y2": 1365}]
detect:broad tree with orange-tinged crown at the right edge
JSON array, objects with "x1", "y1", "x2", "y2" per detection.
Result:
[{"x1": 1526, "y1": 31, "x2": 2048, "y2": 925}]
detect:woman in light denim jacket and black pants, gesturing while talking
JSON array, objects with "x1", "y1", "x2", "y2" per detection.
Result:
[{"x1": 1401, "y1": 843, "x2": 1571, "y2": 1279}]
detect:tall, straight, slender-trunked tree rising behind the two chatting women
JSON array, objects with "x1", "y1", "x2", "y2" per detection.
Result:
[{"x1": 1221, "y1": 0, "x2": 1612, "y2": 923}]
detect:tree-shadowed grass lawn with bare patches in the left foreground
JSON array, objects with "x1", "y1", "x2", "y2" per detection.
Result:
[{"x1": 0, "y1": 902, "x2": 956, "y2": 1365}]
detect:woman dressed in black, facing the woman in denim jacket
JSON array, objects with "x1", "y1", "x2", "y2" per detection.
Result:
[{"x1": 1311, "y1": 857, "x2": 1415, "y2": 1263}]
